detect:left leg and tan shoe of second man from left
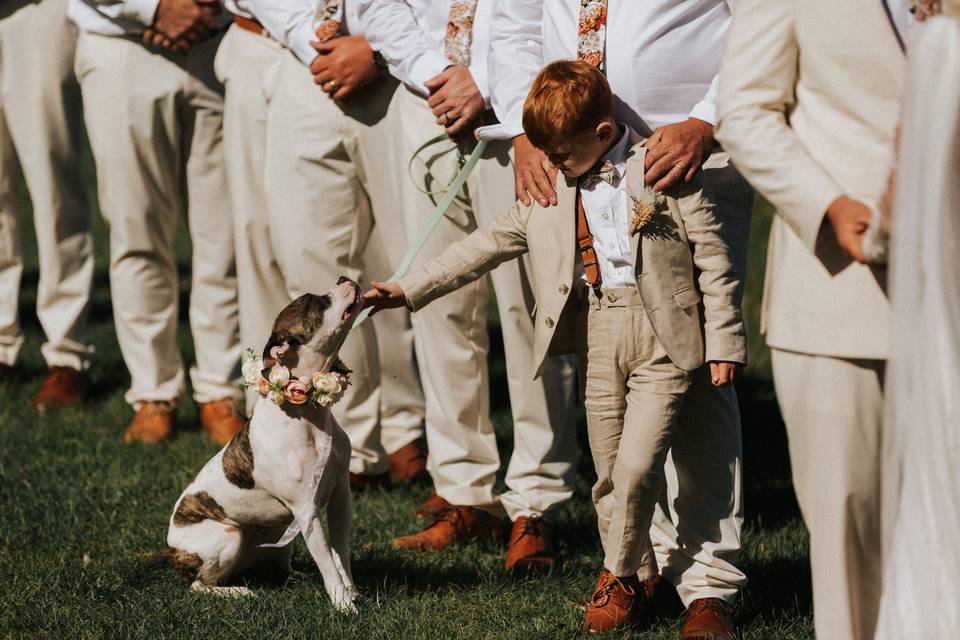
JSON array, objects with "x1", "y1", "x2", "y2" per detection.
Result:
[{"x1": 76, "y1": 33, "x2": 185, "y2": 441}]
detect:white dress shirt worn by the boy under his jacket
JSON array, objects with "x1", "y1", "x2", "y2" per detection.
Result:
[{"x1": 577, "y1": 125, "x2": 637, "y2": 290}]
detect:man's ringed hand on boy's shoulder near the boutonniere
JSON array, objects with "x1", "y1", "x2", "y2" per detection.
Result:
[{"x1": 643, "y1": 118, "x2": 716, "y2": 191}]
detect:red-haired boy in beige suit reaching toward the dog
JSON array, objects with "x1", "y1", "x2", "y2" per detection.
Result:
[{"x1": 365, "y1": 60, "x2": 746, "y2": 632}]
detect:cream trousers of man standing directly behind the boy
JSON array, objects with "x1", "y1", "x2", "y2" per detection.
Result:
[{"x1": 650, "y1": 158, "x2": 753, "y2": 606}]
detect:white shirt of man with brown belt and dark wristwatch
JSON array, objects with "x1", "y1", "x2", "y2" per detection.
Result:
[{"x1": 243, "y1": 0, "x2": 360, "y2": 66}]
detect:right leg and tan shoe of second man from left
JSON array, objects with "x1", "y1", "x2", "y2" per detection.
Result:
[{"x1": 181, "y1": 38, "x2": 245, "y2": 444}]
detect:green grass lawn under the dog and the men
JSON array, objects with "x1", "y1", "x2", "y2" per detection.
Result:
[{"x1": 0, "y1": 142, "x2": 813, "y2": 640}]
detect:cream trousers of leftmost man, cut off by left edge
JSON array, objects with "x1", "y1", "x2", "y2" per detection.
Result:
[{"x1": 0, "y1": 0, "x2": 93, "y2": 369}]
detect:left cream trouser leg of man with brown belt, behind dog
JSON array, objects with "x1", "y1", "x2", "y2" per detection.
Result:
[{"x1": 216, "y1": 25, "x2": 290, "y2": 413}]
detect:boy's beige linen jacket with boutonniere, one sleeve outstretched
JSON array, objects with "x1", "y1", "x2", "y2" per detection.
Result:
[{"x1": 399, "y1": 140, "x2": 746, "y2": 376}]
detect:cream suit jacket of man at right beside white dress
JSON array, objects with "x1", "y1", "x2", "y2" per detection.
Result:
[{"x1": 717, "y1": 0, "x2": 905, "y2": 359}]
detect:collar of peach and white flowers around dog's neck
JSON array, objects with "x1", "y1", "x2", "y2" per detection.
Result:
[{"x1": 241, "y1": 347, "x2": 350, "y2": 408}]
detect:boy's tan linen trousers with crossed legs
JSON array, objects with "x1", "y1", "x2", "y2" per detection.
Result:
[{"x1": 577, "y1": 287, "x2": 691, "y2": 580}]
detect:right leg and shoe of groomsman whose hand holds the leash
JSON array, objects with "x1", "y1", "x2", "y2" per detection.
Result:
[{"x1": 467, "y1": 142, "x2": 577, "y2": 568}]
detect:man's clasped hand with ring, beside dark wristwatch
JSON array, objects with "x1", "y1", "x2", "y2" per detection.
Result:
[{"x1": 310, "y1": 36, "x2": 380, "y2": 100}]
